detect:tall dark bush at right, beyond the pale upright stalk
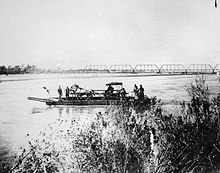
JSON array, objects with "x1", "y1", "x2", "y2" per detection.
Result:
[{"x1": 151, "y1": 78, "x2": 220, "y2": 172}]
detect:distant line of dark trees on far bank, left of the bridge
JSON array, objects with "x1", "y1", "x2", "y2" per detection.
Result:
[{"x1": 0, "y1": 64, "x2": 82, "y2": 75}]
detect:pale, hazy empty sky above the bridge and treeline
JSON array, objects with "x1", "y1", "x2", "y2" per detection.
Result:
[{"x1": 0, "y1": 0, "x2": 220, "y2": 68}]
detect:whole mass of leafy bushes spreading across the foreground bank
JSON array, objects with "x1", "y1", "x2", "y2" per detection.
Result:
[{"x1": 13, "y1": 78, "x2": 220, "y2": 173}]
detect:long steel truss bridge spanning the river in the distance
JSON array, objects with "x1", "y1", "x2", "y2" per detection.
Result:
[{"x1": 82, "y1": 64, "x2": 220, "y2": 74}]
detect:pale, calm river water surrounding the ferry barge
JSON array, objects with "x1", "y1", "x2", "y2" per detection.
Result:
[{"x1": 0, "y1": 74, "x2": 219, "y2": 166}]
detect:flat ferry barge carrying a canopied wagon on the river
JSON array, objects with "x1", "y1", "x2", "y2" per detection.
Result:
[{"x1": 28, "y1": 82, "x2": 134, "y2": 106}]
